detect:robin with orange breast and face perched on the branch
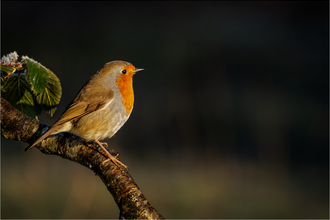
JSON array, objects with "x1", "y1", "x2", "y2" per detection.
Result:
[{"x1": 25, "y1": 60, "x2": 143, "y2": 168}]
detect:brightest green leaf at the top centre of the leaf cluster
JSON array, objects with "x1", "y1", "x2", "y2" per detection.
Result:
[{"x1": 24, "y1": 58, "x2": 52, "y2": 95}]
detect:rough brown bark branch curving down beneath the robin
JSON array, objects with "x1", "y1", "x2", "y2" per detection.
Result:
[{"x1": 1, "y1": 98, "x2": 163, "y2": 219}]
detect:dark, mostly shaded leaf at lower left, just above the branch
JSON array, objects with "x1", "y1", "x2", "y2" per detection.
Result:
[{"x1": 2, "y1": 74, "x2": 41, "y2": 119}]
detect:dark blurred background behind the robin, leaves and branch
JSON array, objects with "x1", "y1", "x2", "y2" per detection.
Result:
[{"x1": 1, "y1": 1, "x2": 329, "y2": 218}]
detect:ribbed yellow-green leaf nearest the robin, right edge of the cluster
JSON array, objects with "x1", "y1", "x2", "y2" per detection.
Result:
[{"x1": 37, "y1": 70, "x2": 62, "y2": 117}]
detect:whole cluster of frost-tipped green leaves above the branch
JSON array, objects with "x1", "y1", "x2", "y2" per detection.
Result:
[{"x1": 1, "y1": 53, "x2": 62, "y2": 118}]
